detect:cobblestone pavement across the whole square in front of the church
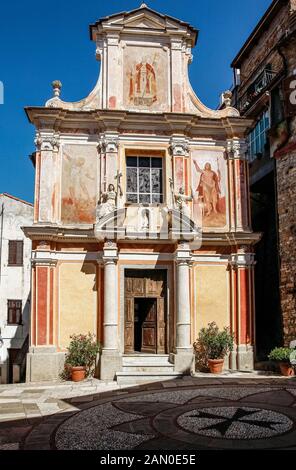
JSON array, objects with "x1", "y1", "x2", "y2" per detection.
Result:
[{"x1": 0, "y1": 374, "x2": 296, "y2": 450}]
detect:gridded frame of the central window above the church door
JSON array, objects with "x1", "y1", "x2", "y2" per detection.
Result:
[{"x1": 125, "y1": 152, "x2": 165, "y2": 206}]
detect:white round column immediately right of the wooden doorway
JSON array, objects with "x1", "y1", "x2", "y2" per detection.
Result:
[{"x1": 174, "y1": 242, "x2": 194, "y2": 374}]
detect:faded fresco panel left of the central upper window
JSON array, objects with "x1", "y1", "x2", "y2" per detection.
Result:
[{"x1": 61, "y1": 145, "x2": 98, "y2": 224}]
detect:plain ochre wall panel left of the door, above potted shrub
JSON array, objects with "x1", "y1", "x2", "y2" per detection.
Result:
[{"x1": 59, "y1": 262, "x2": 97, "y2": 348}]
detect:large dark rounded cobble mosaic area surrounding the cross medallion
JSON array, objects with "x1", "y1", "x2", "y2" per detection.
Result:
[{"x1": 54, "y1": 385, "x2": 296, "y2": 450}]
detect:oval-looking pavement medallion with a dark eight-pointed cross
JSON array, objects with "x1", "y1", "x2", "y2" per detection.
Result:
[{"x1": 177, "y1": 406, "x2": 293, "y2": 439}]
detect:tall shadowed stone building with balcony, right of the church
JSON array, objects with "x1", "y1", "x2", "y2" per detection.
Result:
[{"x1": 232, "y1": 0, "x2": 296, "y2": 359}]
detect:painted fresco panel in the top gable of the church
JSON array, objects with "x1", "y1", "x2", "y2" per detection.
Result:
[{"x1": 123, "y1": 46, "x2": 168, "y2": 111}]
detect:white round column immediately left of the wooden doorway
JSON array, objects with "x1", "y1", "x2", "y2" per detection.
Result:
[{"x1": 100, "y1": 241, "x2": 122, "y2": 381}]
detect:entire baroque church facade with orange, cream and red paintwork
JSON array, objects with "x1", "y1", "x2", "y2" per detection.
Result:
[{"x1": 24, "y1": 4, "x2": 259, "y2": 381}]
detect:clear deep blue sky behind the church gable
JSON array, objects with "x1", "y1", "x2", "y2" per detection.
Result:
[{"x1": 0, "y1": 0, "x2": 271, "y2": 202}]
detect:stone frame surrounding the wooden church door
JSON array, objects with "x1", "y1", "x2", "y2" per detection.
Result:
[{"x1": 119, "y1": 261, "x2": 175, "y2": 355}]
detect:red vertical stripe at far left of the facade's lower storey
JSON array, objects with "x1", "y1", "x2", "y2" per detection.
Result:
[{"x1": 36, "y1": 267, "x2": 48, "y2": 346}]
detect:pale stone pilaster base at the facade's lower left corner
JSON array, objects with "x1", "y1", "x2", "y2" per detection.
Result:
[{"x1": 26, "y1": 346, "x2": 65, "y2": 382}]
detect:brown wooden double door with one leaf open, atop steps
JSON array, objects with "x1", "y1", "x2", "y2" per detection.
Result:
[{"x1": 124, "y1": 270, "x2": 166, "y2": 354}]
